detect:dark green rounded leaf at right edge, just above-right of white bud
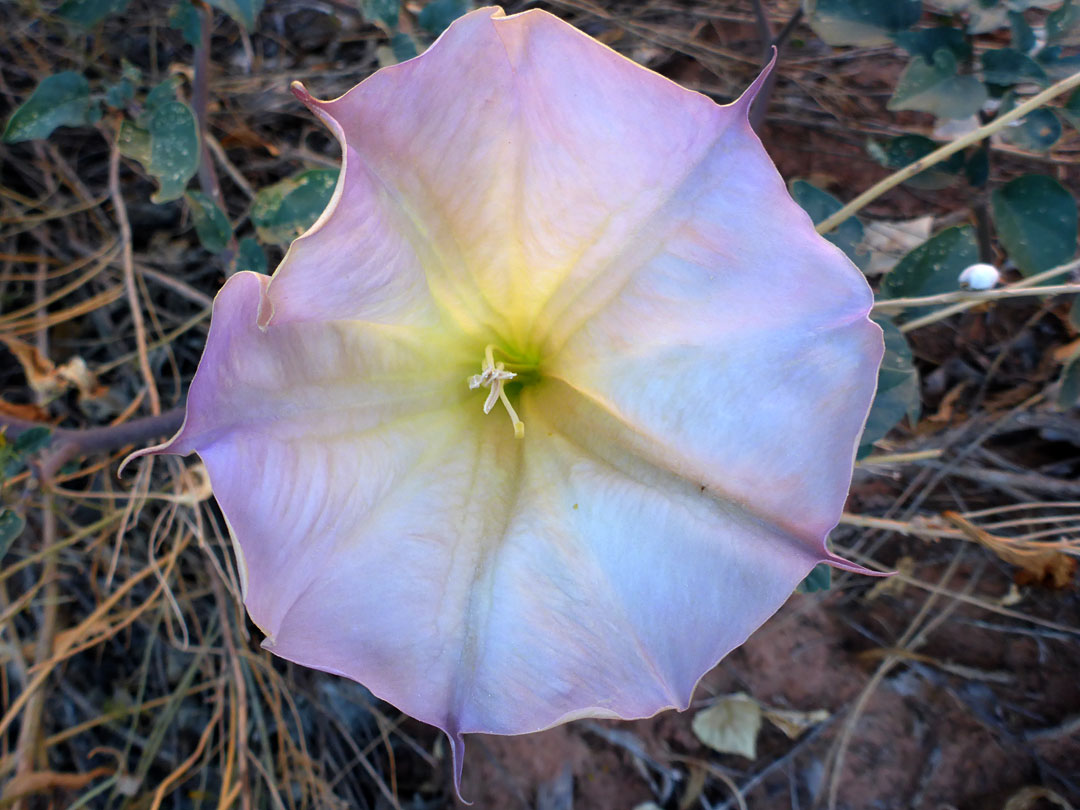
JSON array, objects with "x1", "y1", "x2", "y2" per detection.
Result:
[{"x1": 990, "y1": 174, "x2": 1077, "y2": 275}]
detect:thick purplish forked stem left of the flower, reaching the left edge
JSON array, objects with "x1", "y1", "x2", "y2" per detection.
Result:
[{"x1": 0, "y1": 407, "x2": 185, "y2": 481}]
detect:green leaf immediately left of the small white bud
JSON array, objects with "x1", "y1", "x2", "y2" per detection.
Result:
[{"x1": 880, "y1": 225, "x2": 978, "y2": 318}]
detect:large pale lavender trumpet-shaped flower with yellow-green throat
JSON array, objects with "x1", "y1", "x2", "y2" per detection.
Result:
[{"x1": 130, "y1": 9, "x2": 881, "y2": 794}]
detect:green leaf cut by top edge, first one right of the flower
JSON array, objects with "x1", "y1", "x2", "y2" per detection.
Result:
[{"x1": 802, "y1": 0, "x2": 922, "y2": 45}]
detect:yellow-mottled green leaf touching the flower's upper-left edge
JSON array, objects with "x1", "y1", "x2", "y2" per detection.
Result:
[{"x1": 252, "y1": 168, "x2": 338, "y2": 245}]
